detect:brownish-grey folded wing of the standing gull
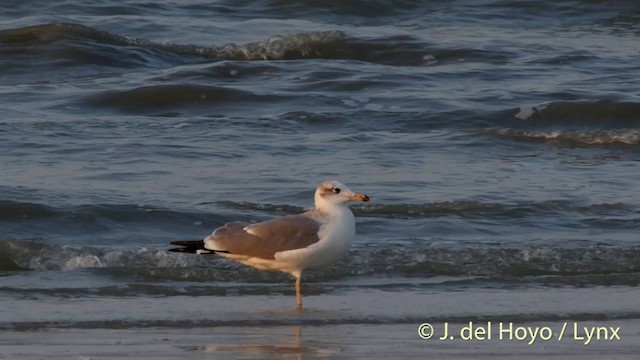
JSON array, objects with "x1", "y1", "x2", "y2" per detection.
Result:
[{"x1": 205, "y1": 214, "x2": 322, "y2": 259}]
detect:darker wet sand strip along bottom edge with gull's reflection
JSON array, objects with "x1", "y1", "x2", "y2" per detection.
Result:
[{"x1": 0, "y1": 319, "x2": 640, "y2": 359}]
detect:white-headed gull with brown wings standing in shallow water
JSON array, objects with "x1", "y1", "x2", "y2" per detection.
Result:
[{"x1": 169, "y1": 180, "x2": 370, "y2": 309}]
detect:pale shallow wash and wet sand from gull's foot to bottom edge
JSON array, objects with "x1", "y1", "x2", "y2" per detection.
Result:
[{"x1": 5, "y1": 287, "x2": 640, "y2": 359}]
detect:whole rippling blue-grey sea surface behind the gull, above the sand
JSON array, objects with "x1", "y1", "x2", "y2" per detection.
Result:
[{"x1": 0, "y1": 0, "x2": 640, "y2": 355}]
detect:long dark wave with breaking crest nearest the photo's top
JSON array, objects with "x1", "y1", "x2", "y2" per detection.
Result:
[{"x1": 0, "y1": 23, "x2": 508, "y2": 67}]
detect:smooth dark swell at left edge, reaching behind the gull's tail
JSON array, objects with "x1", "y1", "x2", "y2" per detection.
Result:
[{"x1": 0, "y1": 201, "x2": 233, "y2": 244}]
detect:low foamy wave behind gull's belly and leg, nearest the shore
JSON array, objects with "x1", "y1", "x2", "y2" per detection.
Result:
[{"x1": 0, "y1": 239, "x2": 640, "y2": 285}]
